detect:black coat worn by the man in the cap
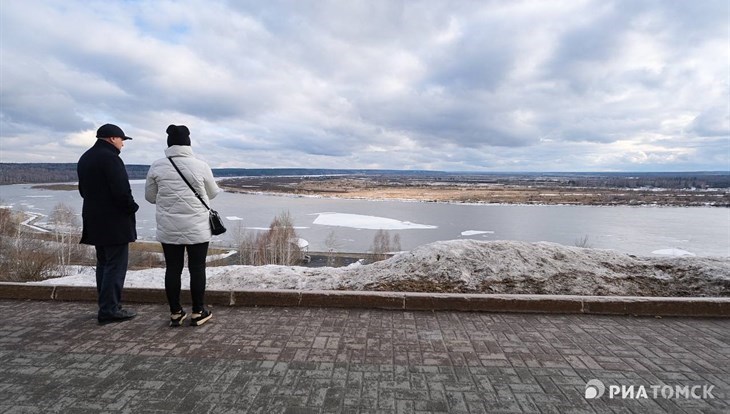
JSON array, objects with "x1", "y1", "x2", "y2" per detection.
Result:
[{"x1": 76, "y1": 139, "x2": 139, "y2": 246}]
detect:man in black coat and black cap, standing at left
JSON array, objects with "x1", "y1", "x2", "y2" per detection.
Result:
[{"x1": 76, "y1": 124, "x2": 139, "y2": 324}]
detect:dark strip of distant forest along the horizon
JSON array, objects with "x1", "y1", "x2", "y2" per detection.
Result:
[{"x1": 0, "y1": 163, "x2": 730, "y2": 189}]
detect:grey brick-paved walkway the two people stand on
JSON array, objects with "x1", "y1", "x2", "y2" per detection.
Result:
[{"x1": 0, "y1": 300, "x2": 730, "y2": 414}]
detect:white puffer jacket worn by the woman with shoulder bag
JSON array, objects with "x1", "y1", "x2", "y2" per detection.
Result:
[{"x1": 145, "y1": 145, "x2": 221, "y2": 244}]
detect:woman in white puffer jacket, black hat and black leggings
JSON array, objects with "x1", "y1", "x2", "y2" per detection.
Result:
[{"x1": 145, "y1": 125, "x2": 221, "y2": 326}]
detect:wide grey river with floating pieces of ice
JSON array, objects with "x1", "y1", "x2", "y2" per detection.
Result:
[{"x1": 0, "y1": 180, "x2": 730, "y2": 257}]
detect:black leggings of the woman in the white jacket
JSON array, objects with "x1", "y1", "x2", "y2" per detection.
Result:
[{"x1": 162, "y1": 242, "x2": 208, "y2": 313}]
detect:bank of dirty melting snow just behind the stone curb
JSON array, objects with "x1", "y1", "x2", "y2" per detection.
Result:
[{"x1": 33, "y1": 240, "x2": 730, "y2": 297}]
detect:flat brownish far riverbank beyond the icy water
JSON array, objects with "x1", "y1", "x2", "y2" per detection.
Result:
[{"x1": 219, "y1": 176, "x2": 730, "y2": 207}]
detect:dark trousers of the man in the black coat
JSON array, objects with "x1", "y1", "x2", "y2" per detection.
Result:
[{"x1": 94, "y1": 243, "x2": 129, "y2": 318}]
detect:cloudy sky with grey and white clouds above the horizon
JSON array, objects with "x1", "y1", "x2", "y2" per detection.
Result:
[{"x1": 0, "y1": 0, "x2": 730, "y2": 171}]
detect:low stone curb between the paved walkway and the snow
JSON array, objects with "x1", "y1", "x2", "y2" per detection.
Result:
[{"x1": 0, "y1": 283, "x2": 730, "y2": 317}]
